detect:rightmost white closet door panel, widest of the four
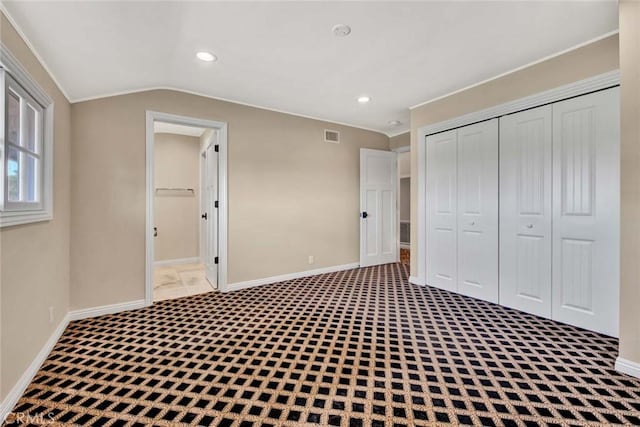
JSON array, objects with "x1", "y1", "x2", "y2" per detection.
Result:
[{"x1": 553, "y1": 88, "x2": 620, "y2": 336}]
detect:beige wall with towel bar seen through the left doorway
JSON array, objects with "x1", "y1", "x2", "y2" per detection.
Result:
[{"x1": 153, "y1": 133, "x2": 200, "y2": 261}]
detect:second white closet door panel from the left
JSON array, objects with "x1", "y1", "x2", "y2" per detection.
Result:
[{"x1": 458, "y1": 119, "x2": 499, "y2": 303}]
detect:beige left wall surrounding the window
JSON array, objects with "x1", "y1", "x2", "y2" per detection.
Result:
[{"x1": 0, "y1": 13, "x2": 70, "y2": 399}]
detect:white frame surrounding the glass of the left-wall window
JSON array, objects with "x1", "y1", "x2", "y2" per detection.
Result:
[{"x1": 0, "y1": 44, "x2": 54, "y2": 227}]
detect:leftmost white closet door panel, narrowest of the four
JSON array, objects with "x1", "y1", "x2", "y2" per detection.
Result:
[{"x1": 426, "y1": 130, "x2": 457, "y2": 292}]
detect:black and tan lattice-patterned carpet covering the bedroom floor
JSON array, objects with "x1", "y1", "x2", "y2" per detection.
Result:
[{"x1": 9, "y1": 264, "x2": 640, "y2": 427}]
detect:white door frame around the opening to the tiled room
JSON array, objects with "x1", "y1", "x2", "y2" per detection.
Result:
[{"x1": 144, "y1": 110, "x2": 228, "y2": 306}]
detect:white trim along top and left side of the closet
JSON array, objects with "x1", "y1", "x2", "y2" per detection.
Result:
[{"x1": 415, "y1": 70, "x2": 620, "y2": 283}]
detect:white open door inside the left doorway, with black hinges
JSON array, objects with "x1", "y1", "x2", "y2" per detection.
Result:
[{"x1": 202, "y1": 143, "x2": 218, "y2": 288}]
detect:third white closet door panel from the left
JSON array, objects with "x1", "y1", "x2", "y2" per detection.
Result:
[{"x1": 500, "y1": 105, "x2": 552, "y2": 318}]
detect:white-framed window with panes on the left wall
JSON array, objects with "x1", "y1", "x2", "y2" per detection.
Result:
[{"x1": 0, "y1": 50, "x2": 53, "y2": 226}]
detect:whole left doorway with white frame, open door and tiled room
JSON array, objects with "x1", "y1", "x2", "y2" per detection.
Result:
[{"x1": 145, "y1": 111, "x2": 227, "y2": 305}]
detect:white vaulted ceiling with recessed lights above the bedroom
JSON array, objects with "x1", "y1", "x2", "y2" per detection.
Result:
[{"x1": 3, "y1": 0, "x2": 618, "y2": 135}]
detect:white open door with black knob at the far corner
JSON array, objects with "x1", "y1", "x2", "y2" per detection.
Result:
[{"x1": 360, "y1": 148, "x2": 398, "y2": 267}]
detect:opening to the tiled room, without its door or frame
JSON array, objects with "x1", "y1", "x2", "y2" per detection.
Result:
[{"x1": 153, "y1": 121, "x2": 213, "y2": 301}]
